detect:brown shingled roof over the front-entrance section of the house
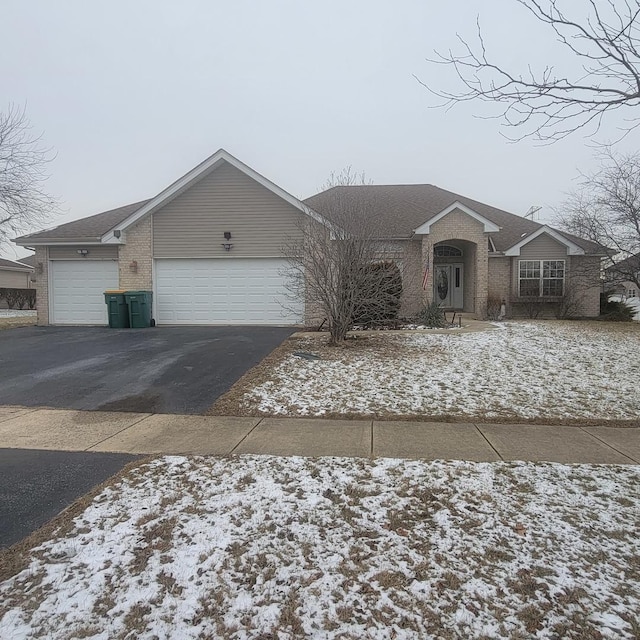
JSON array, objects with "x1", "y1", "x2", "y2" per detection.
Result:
[{"x1": 304, "y1": 184, "x2": 603, "y2": 254}]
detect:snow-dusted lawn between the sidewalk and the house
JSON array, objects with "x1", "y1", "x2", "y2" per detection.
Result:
[{"x1": 235, "y1": 321, "x2": 640, "y2": 422}]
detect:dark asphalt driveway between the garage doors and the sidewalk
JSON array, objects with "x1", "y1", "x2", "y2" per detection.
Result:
[{"x1": 0, "y1": 327, "x2": 295, "y2": 414}]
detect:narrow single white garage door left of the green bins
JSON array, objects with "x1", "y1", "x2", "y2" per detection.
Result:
[{"x1": 49, "y1": 260, "x2": 118, "y2": 324}]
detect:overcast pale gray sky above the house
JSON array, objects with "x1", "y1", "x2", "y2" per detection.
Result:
[{"x1": 0, "y1": 0, "x2": 638, "y2": 257}]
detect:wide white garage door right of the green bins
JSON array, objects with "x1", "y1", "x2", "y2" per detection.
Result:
[{"x1": 154, "y1": 258, "x2": 302, "y2": 325}]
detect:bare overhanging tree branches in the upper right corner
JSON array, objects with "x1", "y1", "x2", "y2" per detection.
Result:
[{"x1": 422, "y1": 0, "x2": 640, "y2": 142}]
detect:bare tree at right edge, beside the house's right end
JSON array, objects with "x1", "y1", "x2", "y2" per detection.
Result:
[{"x1": 558, "y1": 147, "x2": 640, "y2": 288}]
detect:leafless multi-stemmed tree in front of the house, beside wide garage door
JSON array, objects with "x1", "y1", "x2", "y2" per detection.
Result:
[{"x1": 283, "y1": 167, "x2": 402, "y2": 344}]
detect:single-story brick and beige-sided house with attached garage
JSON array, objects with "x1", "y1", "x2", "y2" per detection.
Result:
[{"x1": 15, "y1": 150, "x2": 602, "y2": 325}]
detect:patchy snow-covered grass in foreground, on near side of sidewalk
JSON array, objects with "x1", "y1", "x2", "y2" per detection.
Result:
[{"x1": 0, "y1": 457, "x2": 640, "y2": 640}]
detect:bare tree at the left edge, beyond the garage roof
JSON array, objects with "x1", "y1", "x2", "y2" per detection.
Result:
[{"x1": 0, "y1": 105, "x2": 56, "y2": 246}]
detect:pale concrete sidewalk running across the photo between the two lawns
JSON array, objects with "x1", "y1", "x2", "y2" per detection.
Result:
[{"x1": 0, "y1": 406, "x2": 640, "y2": 464}]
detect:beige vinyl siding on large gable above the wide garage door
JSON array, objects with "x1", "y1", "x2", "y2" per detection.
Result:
[{"x1": 153, "y1": 163, "x2": 304, "y2": 258}]
